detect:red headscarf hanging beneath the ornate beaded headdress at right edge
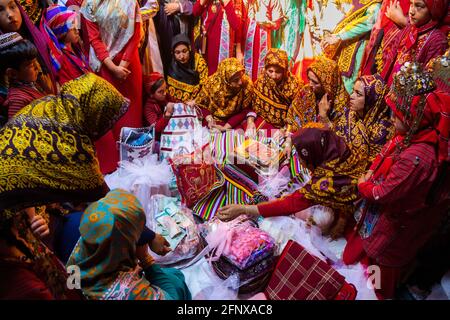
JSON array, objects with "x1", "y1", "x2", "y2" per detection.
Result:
[{"x1": 386, "y1": 90, "x2": 450, "y2": 163}]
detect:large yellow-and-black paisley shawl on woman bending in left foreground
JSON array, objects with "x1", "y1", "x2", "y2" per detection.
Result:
[{"x1": 0, "y1": 73, "x2": 129, "y2": 218}]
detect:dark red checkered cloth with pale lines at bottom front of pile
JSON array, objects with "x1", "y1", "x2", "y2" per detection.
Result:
[{"x1": 265, "y1": 240, "x2": 356, "y2": 300}]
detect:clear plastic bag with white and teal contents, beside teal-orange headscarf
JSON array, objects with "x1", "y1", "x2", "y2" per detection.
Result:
[{"x1": 147, "y1": 195, "x2": 202, "y2": 265}]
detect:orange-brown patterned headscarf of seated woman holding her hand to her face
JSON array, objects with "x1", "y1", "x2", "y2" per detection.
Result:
[{"x1": 288, "y1": 56, "x2": 350, "y2": 131}]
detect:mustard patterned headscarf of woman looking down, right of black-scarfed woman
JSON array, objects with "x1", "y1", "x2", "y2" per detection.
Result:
[{"x1": 195, "y1": 58, "x2": 253, "y2": 120}]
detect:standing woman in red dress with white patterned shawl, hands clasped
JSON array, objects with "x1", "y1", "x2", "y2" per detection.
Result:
[{"x1": 81, "y1": 0, "x2": 142, "y2": 173}]
